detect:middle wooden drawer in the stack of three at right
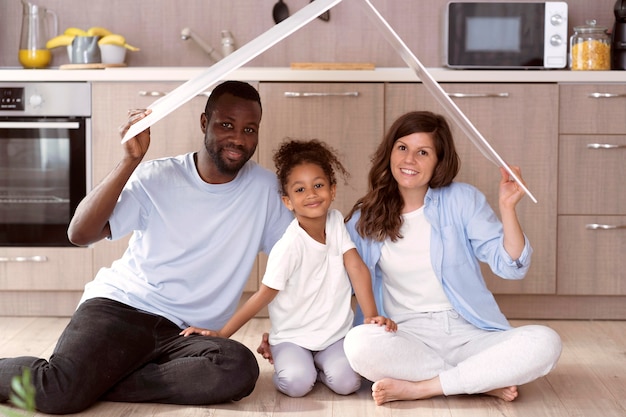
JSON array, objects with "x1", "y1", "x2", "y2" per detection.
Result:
[{"x1": 558, "y1": 135, "x2": 626, "y2": 215}]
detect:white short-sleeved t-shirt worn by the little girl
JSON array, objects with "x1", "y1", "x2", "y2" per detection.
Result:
[{"x1": 262, "y1": 210, "x2": 355, "y2": 351}]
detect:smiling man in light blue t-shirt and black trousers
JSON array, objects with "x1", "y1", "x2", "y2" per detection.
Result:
[{"x1": 0, "y1": 81, "x2": 293, "y2": 414}]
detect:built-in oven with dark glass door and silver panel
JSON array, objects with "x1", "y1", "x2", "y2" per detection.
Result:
[{"x1": 0, "y1": 82, "x2": 91, "y2": 246}]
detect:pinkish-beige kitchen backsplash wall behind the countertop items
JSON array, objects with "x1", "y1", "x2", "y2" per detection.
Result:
[{"x1": 0, "y1": 0, "x2": 615, "y2": 68}]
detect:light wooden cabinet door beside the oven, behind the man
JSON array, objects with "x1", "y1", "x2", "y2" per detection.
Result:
[{"x1": 92, "y1": 82, "x2": 258, "y2": 291}]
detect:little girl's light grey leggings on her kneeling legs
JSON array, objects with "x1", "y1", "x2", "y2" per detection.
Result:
[{"x1": 271, "y1": 339, "x2": 361, "y2": 397}]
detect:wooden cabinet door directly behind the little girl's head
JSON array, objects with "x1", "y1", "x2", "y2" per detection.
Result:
[{"x1": 258, "y1": 82, "x2": 384, "y2": 215}]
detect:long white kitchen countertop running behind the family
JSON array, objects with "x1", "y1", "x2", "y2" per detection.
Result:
[{"x1": 0, "y1": 67, "x2": 626, "y2": 83}]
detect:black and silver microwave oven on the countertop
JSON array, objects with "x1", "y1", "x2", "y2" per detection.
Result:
[{"x1": 443, "y1": 1, "x2": 568, "y2": 69}]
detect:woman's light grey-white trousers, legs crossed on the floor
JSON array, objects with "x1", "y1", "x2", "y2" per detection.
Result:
[{"x1": 344, "y1": 310, "x2": 561, "y2": 395}]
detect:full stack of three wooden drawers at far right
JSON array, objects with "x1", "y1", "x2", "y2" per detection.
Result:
[{"x1": 557, "y1": 84, "x2": 626, "y2": 296}]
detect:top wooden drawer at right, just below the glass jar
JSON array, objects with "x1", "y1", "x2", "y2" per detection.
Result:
[{"x1": 559, "y1": 84, "x2": 626, "y2": 134}]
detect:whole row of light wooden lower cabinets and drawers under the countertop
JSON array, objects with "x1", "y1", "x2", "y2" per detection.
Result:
[{"x1": 0, "y1": 82, "x2": 626, "y2": 319}]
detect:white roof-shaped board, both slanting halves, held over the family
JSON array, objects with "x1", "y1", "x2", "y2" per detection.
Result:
[{"x1": 122, "y1": 0, "x2": 537, "y2": 203}]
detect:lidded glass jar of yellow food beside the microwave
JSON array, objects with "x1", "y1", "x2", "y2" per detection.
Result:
[{"x1": 570, "y1": 20, "x2": 611, "y2": 71}]
